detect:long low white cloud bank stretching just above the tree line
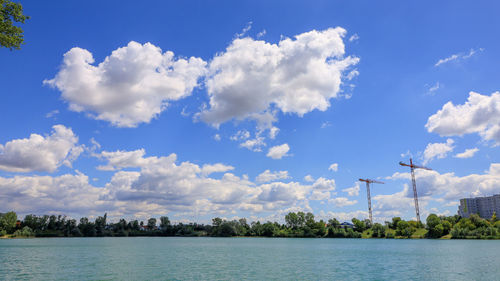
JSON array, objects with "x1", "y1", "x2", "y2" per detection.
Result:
[{"x1": 0, "y1": 144, "x2": 368, "y2": 219}]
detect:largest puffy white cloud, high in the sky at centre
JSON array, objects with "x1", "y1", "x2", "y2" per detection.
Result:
[{"x1": 200, "y1": 27, "x2": 359, "y2": 128}]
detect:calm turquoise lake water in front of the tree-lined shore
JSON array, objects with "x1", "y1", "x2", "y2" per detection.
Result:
[{"x1": 0, "y1": 237, "x2": 500, "y2": 280}]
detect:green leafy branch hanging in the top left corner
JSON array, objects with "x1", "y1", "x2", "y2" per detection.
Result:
[{"x1": 0, "y1": 0, "x2": 29, "y2": 50}]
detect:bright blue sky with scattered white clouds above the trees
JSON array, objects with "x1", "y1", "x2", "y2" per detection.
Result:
[{"x1": 0, "y1": 1, "x2": 500, "y2": 222}]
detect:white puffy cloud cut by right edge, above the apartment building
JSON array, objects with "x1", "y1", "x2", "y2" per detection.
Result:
[{"x1": 425, "y1": 92, "x2": 500, "y2": 145}]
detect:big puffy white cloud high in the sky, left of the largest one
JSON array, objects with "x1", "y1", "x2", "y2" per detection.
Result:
[{"x1": 44, "y1": 41, "x2": 206, "y2": 127}]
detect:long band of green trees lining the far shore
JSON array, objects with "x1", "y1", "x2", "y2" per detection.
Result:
[{"x1": 0, "y1": 212, "x2": 500, "y2": 239}]
